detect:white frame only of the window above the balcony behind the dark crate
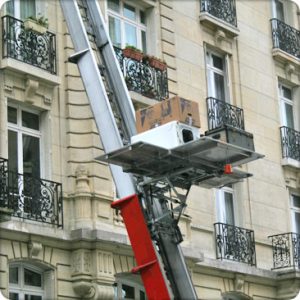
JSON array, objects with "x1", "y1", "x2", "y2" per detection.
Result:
[{"x1": 205, "y1": 49, "x2": 230, "y2": 103}]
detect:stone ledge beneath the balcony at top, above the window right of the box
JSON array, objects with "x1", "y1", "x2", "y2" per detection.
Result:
[{"x1": 200, "y1": 12, "x2": 240, "y2": 38}]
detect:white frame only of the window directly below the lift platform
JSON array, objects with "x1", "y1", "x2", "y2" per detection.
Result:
[{"x1": 216, "y1": 186, "x2": 236, "y2": 226}]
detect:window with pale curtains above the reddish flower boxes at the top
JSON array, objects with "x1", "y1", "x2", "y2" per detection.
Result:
[{"x1": 107, "y1": 0, "x2": 147, "y2": 52}]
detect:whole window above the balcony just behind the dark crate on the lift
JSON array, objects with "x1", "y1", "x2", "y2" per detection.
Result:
[{"x1": 206, "y1": 51, "x2": 228, "y2": 101}]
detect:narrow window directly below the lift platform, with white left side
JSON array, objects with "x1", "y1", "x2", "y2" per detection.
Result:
[{"x1": 217, "y1": 185, "x2": 235, "y2": 225}]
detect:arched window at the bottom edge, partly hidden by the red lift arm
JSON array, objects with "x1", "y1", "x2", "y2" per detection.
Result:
[{"x1": 115, "y1": 274, "x2": 147, "y2": 300}]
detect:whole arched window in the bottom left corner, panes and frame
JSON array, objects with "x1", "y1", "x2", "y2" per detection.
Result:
[{"x1": 9, "y1": 263, "x2": 45, "y2": 300}]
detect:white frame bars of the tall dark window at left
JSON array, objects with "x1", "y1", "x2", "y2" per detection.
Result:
[{"x1": 7, "y1": 104, "x2": 44, "y2": 178}]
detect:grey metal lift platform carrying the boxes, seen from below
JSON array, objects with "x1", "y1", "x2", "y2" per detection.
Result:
[{"x1": 98, "y1": 136, "x2": 263, "y2": 189}]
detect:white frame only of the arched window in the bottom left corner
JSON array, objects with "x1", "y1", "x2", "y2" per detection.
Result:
[{"x1": 9, "y1": 262, "x2": 46, "y2": 300}]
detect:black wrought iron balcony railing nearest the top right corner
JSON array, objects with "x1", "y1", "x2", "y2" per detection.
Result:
[{"x1": 271, "y1": 19, "x2": 300, "y2": 59}]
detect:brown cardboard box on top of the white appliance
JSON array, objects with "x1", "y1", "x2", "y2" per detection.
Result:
[{"x1": 136, "y1": 96, "x2": 200, "y2": 133}]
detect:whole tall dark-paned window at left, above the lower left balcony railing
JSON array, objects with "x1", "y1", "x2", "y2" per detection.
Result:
[{"x1": 7, "y1": 106, "x2": 41, "y2": 178}]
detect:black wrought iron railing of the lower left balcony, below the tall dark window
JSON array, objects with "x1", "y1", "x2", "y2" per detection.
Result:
[{"x1": 0, "y1": 158, "x2": 63, "y2": 227}]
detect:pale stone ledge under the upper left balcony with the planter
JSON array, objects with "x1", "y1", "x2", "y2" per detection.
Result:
[{"x1": 0, "y1": 58, "x2": 61, "y2": 86}]
